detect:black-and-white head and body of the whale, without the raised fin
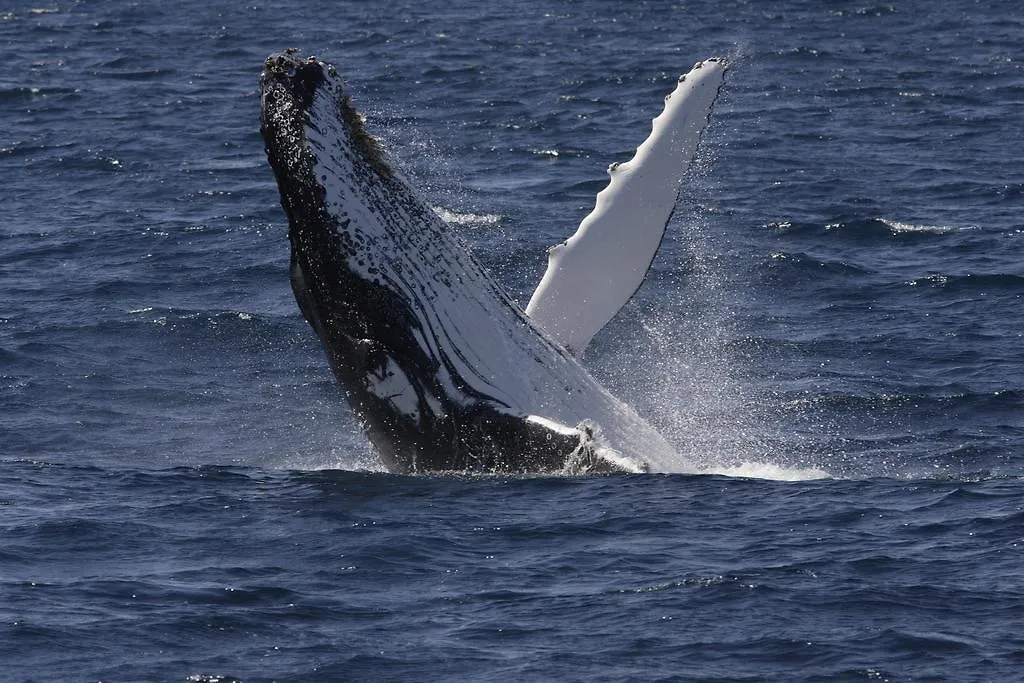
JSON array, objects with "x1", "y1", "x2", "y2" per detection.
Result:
[{"x1": 260, "y1": 52, "x2": 729, "y2": 472}]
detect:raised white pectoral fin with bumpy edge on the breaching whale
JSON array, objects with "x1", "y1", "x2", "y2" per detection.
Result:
[{"x1": 526, "y1": 59, "x2": 728, "y2": 353}]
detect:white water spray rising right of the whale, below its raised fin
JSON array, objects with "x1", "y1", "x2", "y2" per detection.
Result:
[{"x1": 602, "y1": 205, "x2": 829, "y2": 480}]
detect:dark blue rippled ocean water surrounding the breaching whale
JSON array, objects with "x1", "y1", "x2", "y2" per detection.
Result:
[{"x1": 0, "y1": 0, "x2": 1024, "y2": 682}]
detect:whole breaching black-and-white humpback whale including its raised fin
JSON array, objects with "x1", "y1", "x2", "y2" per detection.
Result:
[{"x1": 260, "y1": 50, "x2": 727, "y2": 473}]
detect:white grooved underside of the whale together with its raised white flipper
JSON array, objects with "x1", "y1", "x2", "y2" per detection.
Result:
[{"x1": 292, "y1": 56, "x2": 725, "y2": 472}]
